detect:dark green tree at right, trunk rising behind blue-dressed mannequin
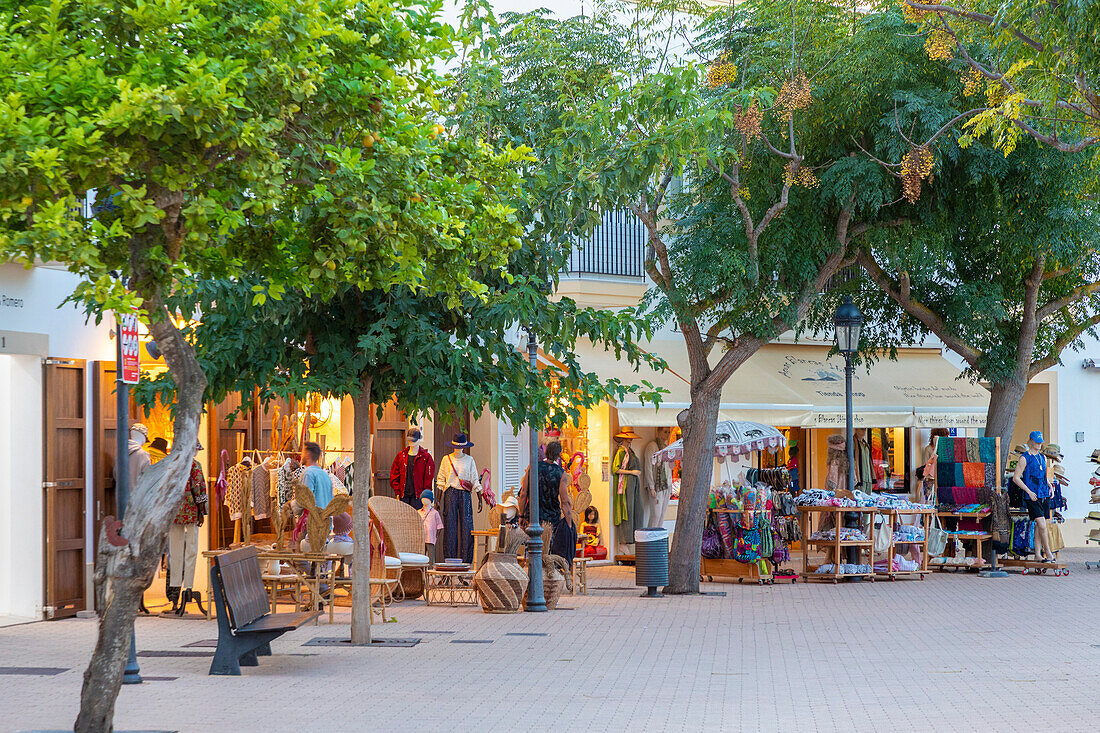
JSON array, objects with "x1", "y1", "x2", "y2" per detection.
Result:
[{"x1": 860, "y1": 140, "x2": 1100, "y2": 456}]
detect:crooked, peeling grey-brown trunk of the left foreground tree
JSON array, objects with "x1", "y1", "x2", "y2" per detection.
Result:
[{"x1": 74, "y1": 305, "x2": 206, "y2": 733}]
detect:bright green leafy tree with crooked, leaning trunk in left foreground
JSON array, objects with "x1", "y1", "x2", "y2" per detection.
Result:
[{"x1": 0, "y1": 0, "x2": 523, "y2": 731}]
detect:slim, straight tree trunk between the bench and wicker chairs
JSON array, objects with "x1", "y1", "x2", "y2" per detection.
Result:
[{"x1": 351, "y1": 376, "x2": 373, "y2": 644}]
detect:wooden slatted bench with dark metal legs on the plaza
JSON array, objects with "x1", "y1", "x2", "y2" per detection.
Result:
[{"x1": 210, "y1": 547, "x2": 321, "y2": 675}]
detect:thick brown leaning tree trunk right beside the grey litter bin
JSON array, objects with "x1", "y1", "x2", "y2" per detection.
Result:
[{"x1": 664, "y1": 385, "x2": 722, "y2": 593}]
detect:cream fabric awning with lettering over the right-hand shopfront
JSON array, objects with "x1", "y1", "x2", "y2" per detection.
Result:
[{"x1": 578, "y1": 339, "x2": 989, "y2": 427}]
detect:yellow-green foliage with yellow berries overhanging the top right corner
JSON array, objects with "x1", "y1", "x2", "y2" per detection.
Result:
[{"x1": 902, "y1": 0, "x2": 1100, "y2": 153}]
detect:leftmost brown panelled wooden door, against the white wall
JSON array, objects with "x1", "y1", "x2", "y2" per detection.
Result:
[{"x1": 42, "y1": 359, "x2": 87, "y2": 619}]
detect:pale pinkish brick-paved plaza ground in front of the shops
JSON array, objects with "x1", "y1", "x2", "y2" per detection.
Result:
[{"x1": 0, "y1": 549, "x2": 1100, "y2": 733}]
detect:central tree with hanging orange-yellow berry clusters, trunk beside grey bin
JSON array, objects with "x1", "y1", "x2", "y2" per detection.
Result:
[{"x1": 495, "y1": 2, "x2": 932, "y2": 593}]
